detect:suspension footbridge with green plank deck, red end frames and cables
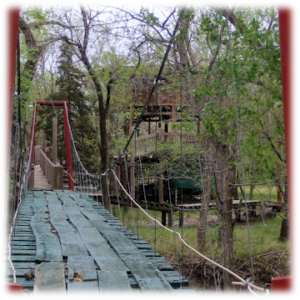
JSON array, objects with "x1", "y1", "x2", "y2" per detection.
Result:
[{"x1": 1, "y1": 1, "x2": 299, "y2": 299}]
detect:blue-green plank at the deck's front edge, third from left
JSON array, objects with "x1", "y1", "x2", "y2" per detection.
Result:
[{"x1": 97, "y1": 271, "x2": 133, "y2": 299}]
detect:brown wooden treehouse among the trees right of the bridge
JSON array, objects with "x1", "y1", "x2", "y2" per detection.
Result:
[{"x1": 121, "y1": 78, "x2": 202, "y2": 204}]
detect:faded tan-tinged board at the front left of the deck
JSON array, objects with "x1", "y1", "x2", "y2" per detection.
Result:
[{"x1": 33, "y1": 262, "x2": 67, "y2": 299}]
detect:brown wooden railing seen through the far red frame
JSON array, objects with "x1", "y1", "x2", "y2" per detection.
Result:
[{"x1": 39, "y1": 149, "x2": 63, "y2": 190}]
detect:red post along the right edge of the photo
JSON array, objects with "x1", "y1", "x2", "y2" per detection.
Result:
[{"x1": 271, "y1": 1, "x2": 299, "y2": 297}]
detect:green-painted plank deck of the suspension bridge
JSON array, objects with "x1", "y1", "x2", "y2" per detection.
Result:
[{"x1": 2, "y1": 189, "x2": 198, "y2": 299}]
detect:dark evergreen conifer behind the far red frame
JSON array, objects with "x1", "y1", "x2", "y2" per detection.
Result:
[{"x1": 39, "y1": 44, "x2": 98, "y2": 171}]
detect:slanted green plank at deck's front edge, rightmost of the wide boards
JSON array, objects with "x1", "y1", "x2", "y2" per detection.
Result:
[{"x1": 121, "y1": 255, "x2": 176, "y2": 299}]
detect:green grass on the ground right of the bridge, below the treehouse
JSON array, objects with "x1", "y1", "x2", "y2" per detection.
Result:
[{"x1": 112, "y1": 200, "x2": 290, "y2": 260}]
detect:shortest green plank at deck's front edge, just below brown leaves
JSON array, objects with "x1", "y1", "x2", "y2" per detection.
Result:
[{"x1": 67, "y1": 281, "x2": 102, "y2": 299}]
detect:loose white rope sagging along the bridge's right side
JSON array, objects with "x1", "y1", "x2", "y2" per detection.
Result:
[{"x1": 111, "y1": 170, "x2": 270, "y2": 299}]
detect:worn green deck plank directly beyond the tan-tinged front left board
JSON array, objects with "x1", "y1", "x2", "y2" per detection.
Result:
[{"x1": 30, "y1": 217, "x2": 63, "y2": 262}]
